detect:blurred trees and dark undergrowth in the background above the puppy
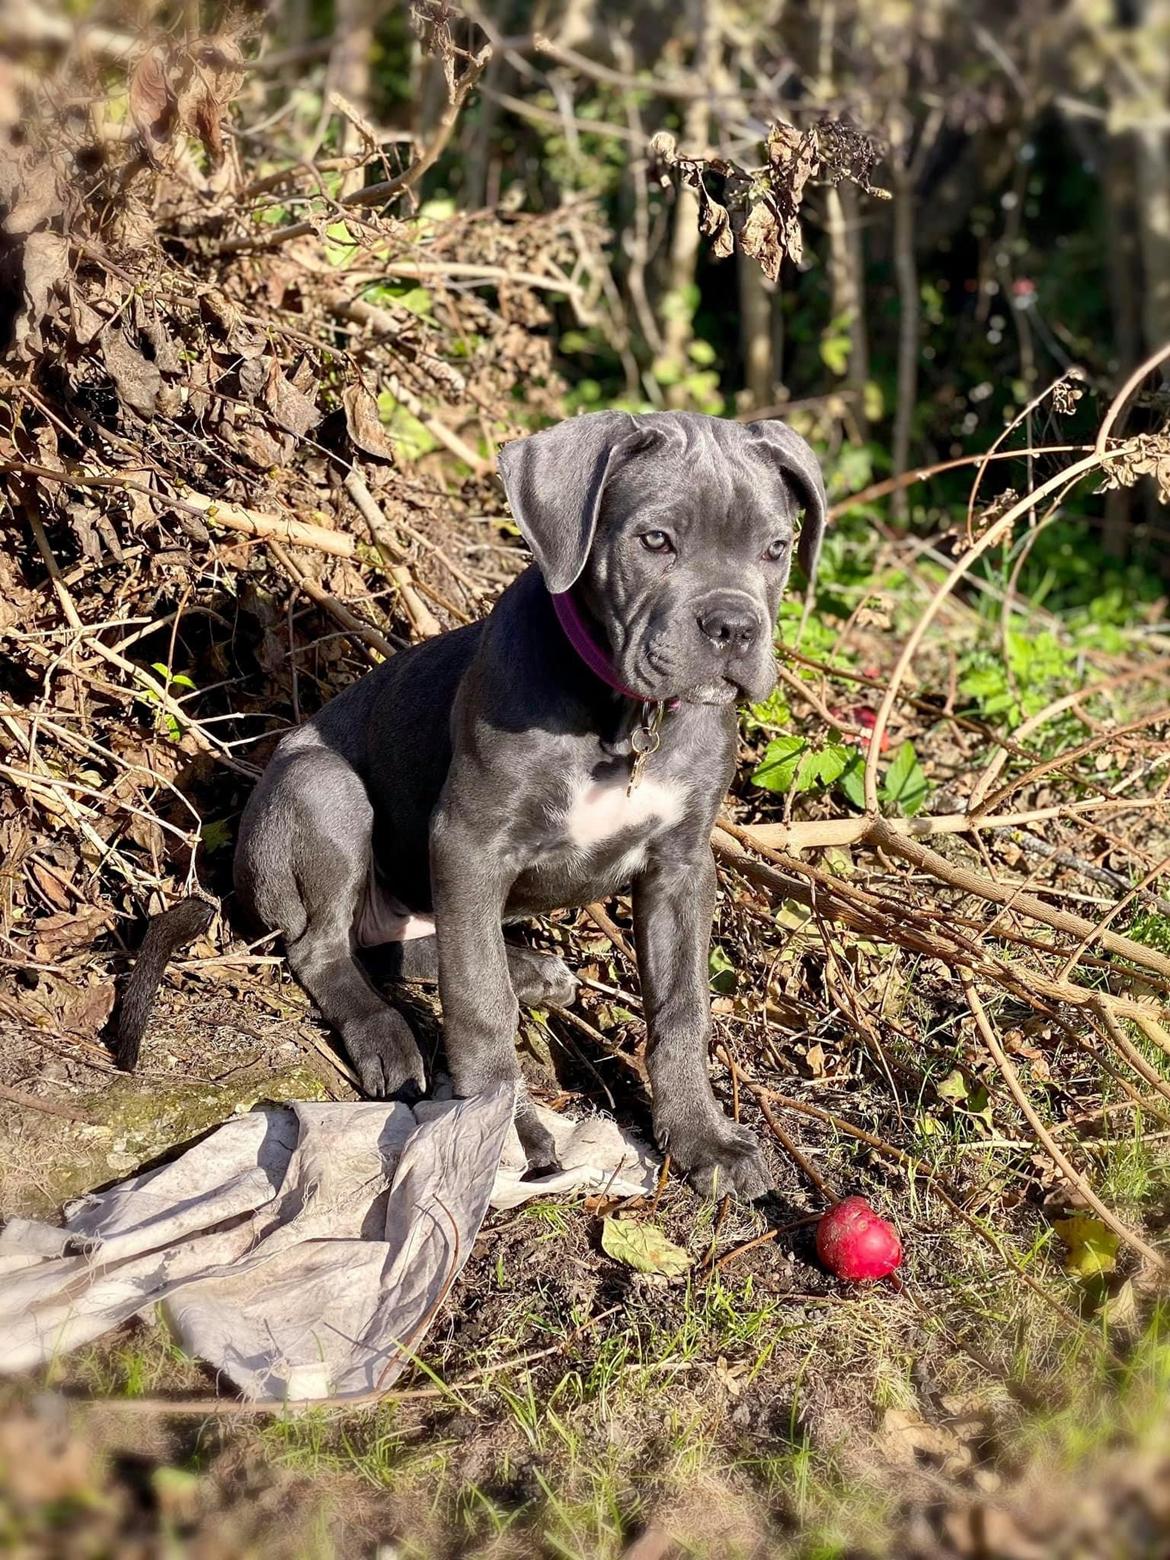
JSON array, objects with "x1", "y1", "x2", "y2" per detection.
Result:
[{"x1": 302, "y1": 0, "x2": 1170, "y2": 602}]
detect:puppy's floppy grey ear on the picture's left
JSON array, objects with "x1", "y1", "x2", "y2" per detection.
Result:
[{"x1": 498, "y1": 412, "x2": 644, "y2": 596}]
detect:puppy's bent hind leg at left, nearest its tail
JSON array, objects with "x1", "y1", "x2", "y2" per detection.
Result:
[{"x1": 236, "y1": 729, "x2": 426, "y2": 1100}]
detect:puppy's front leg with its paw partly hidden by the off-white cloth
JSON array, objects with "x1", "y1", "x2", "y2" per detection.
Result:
[{"x1": 431, "y1": 800, "x2": 558, "y2": 1172}]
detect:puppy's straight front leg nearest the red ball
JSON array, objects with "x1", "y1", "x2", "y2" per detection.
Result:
[{"x1": 633, "y1": 844, "x2": 771, "y2": 1198}]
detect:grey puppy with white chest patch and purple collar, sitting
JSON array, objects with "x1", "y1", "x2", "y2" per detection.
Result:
[{"x1": 124, "y1": 412, "x2": 825, "y2": 1198}]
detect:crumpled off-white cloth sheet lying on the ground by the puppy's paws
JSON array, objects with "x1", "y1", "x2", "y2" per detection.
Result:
[{"x1": 0, "y1": 1089, "x2": 657, "y2": 1402}]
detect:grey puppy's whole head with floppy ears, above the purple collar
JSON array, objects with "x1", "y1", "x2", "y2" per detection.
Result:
[{"x1": 499, "y1": 412, "x2": 827, "y2": 704}]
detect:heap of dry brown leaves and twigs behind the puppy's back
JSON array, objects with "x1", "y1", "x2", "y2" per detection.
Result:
[{"x1": 0, "y1": 5, "x2": 605, "y2": 1036}]
